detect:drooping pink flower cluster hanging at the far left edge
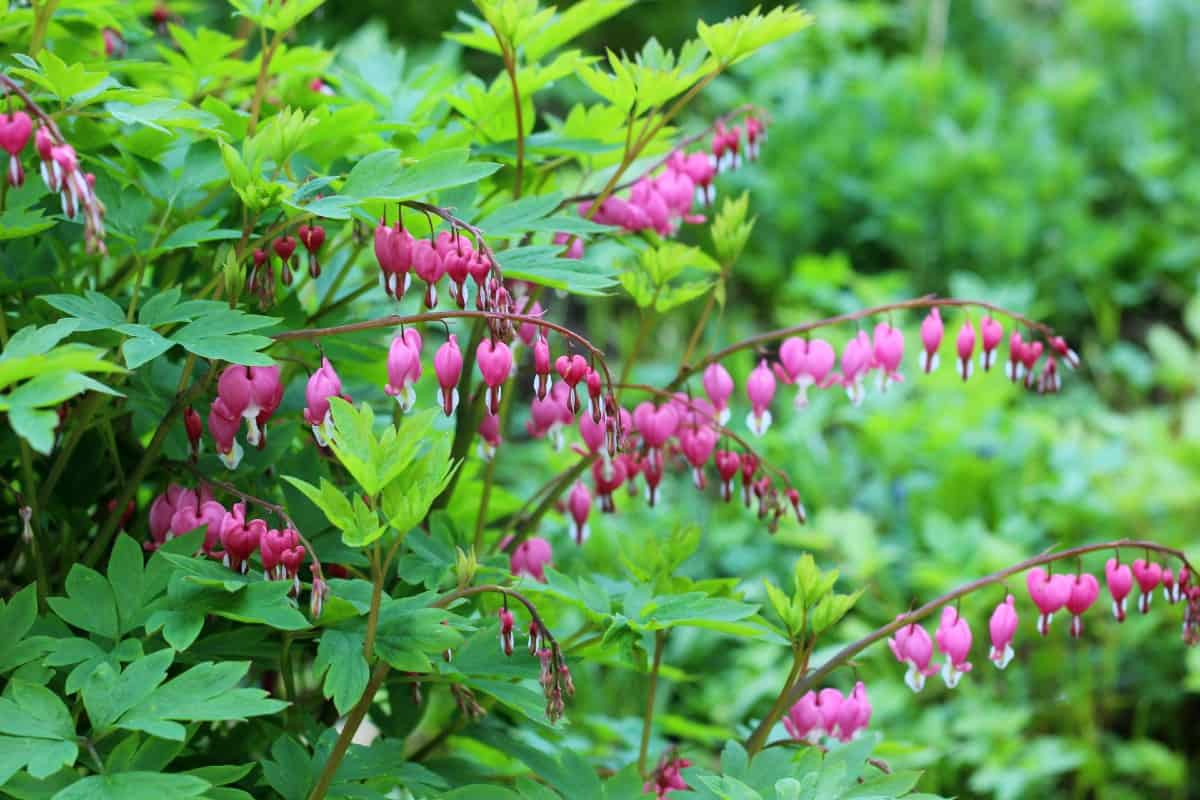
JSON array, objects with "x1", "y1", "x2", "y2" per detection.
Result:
[{"x1": 0, "y1": 86, "x2": 107, "y2": 253}]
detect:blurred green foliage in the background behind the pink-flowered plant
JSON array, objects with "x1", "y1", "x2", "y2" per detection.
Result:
[{"x1": 314, "y1": 0, "x2": 1200, "y2": 800}]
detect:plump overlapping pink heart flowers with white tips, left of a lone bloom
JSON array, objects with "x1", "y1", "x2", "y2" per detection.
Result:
[{"x1": 209, "y1": 363, "x2": 282, "y2": 469}]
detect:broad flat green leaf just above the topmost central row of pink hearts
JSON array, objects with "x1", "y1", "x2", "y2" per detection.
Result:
[{"x1": 342, "y1": 149, "x2": 500, "y2": 200}]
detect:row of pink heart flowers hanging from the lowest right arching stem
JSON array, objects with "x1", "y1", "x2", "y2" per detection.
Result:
[{"x1": 888, "y1": 558, "x2": 1200, "y2": 692}]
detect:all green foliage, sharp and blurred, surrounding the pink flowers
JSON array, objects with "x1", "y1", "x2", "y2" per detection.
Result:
[{"x1": 0, "y1": 0, "x2": 1200, "y2": 800}]
